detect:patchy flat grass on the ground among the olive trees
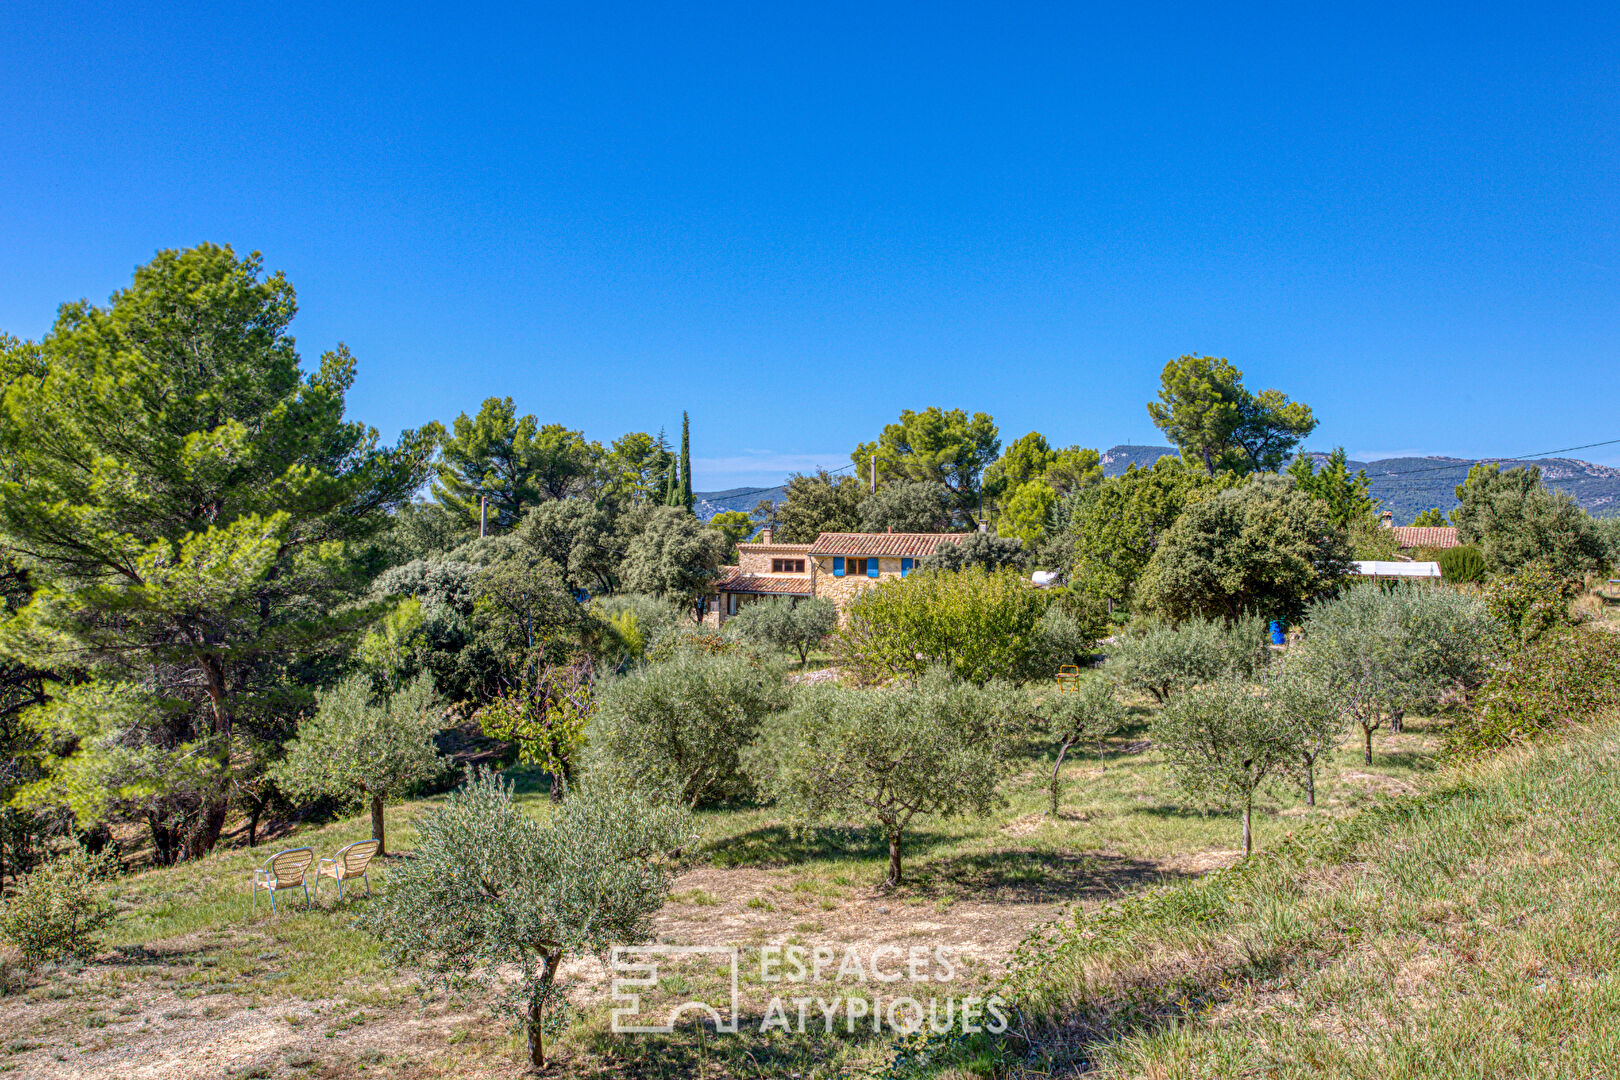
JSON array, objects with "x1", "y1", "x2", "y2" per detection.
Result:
[{"x1": 0, "y1": 688, "x2": 1437, "y2": 1080}]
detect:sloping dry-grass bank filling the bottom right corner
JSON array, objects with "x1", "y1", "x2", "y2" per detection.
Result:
[{"x1": 984, "y1": 712, "x2": 1620, "y2": 1080}]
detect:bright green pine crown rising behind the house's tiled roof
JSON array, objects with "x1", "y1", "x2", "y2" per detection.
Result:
[{"x1": 849, "y1": 406, "x2": 1001, "y2": 513}]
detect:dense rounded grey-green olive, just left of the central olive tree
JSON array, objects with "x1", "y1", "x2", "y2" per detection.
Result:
[{"x1": 588, "y1": 644, "x2": 787, "y2": 806}]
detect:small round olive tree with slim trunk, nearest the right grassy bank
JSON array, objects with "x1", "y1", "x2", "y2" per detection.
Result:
[{"x1": 1152, "y1": 678, "x2": 1301, "y2": 855}]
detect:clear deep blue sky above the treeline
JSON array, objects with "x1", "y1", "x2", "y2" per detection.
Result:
[{"x1": 0, "y1": 0, "x2": 1620, "y2": 487}]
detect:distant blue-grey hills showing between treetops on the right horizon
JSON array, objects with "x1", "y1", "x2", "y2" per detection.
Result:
[{"x1": 1102, "y1": 445, "x2": 1620, "y2": 525}]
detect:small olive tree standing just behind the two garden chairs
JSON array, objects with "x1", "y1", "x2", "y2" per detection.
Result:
[{"x1": 274, "y1": 675, "x2": 446, "y2": 855}]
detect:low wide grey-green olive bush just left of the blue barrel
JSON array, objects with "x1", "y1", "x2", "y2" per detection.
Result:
[{"x1": 1108, "y1": 617, "x2": 1270, "y2": 704}]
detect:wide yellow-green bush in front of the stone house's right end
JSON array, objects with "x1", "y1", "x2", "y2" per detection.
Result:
[{"x1": 834, "y1": 568, "x2": 1051, "y2": 683}]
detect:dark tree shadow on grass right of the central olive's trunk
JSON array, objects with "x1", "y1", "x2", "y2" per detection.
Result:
[{"x1": 909, "y1": 852, "x2": 1194, "y2": 904}]
